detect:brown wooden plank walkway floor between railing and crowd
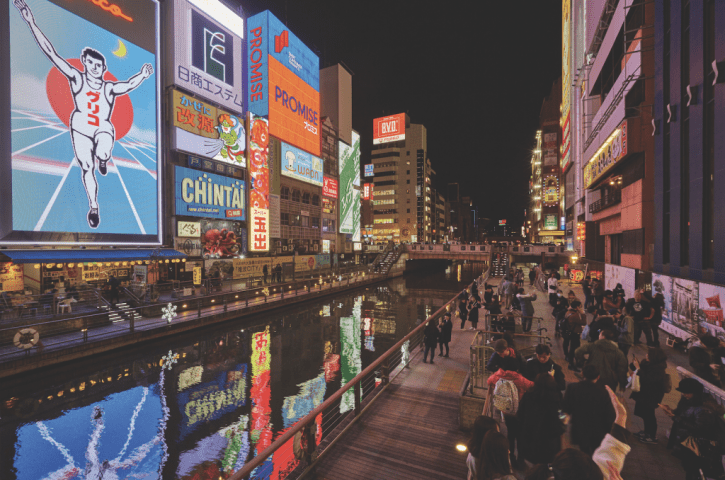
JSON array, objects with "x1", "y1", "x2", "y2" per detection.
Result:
[{"x1": 307, "y1": 279, "x2": 687, "y2": 480}]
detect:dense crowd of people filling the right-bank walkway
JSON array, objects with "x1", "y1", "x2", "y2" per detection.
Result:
[{"x1": 456, "y1": 269, "x2": 725, "y2": 480}]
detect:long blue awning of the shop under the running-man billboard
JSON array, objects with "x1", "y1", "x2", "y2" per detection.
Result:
[{"x1": 0, "y1": 248, "x2": 186, "y2": 263}]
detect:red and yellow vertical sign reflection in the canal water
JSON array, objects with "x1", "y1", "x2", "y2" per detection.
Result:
[{"x1": 251, "y1": 327, "x2": 273, "y2": 479}]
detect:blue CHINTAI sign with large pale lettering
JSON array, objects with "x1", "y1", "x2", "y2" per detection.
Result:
[{"x1": 174, "y1": 166, "x2": 246, "y2": 220}]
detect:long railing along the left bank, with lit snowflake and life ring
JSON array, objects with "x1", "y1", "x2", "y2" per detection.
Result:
[{"x1": 0, "y1": 267, "x2": 387, "y2": 368}]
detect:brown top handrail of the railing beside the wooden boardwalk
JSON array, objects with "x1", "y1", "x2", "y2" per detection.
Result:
[{"x1": 229, "y1": 270, "x2": 490, "y2": 480}]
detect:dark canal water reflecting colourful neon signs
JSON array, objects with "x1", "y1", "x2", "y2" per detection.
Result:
[{"x1": 0, "y1": 263, "x2": 483, "y2": 480}]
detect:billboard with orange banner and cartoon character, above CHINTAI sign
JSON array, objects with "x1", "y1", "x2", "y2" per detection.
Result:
[{"x1": 171, "y1": 90, "x2": 247, "y2": 167}]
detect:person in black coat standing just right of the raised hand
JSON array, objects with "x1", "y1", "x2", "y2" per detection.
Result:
[{"x1": 629, "y1": 347, "x2": 672, "y2": 444}]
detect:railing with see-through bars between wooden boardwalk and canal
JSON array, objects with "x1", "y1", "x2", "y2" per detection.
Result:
[{"x1": 229, "y1": 266, "x2": 488, "y2": 480}]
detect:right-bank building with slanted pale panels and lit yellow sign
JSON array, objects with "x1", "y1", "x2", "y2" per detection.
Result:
[{"x1": 562, "y1": 0, "x2": 656, "y2": 270}]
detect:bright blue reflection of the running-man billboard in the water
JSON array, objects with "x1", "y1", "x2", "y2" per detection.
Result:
[{"x1": 13, "y1": 386, "x2": 166, "y2": 479}]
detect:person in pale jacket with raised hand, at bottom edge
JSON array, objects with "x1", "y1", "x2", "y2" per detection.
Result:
[{"x1": 526, "y1": 387, "x2": 631, "y2": 480}]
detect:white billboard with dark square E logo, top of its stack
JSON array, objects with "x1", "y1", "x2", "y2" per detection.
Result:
[{"x1": 171, "y1": 0, "x2": 246, "y2": 113}]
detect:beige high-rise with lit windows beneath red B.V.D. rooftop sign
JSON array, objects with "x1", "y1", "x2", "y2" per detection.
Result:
[{"x1": 371, "y1": 114, "x2": 434, "y2": 242}]
